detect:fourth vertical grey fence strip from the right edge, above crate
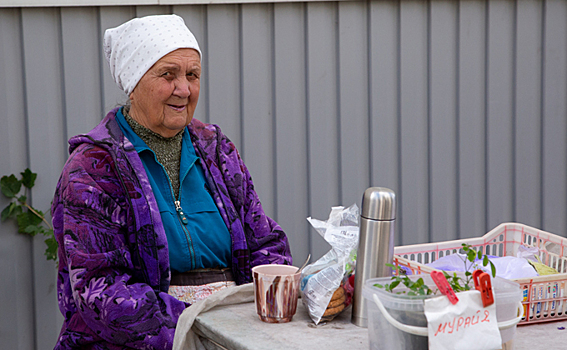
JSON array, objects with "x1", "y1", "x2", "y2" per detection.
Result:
[{"x1": 455, "y1": 1, "x2": 487, "y2": 238}]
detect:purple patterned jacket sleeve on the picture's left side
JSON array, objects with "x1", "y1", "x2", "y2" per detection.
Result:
[{"x1": 52, "y1": 152, "x2": 186, "y2": 349}]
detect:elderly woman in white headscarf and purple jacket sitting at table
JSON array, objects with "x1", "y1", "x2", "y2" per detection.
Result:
[{"x1": 52, "y1": 15, "x2": 292, "y2": 349}]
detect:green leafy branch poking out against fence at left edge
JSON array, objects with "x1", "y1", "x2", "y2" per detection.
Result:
[{"x1": 0, "y1": 169, "x2": 57, "y2": 261}]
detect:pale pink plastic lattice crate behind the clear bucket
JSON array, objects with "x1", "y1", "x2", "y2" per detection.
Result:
[{"x1": 394, "y1": 223, "x2": 567, "y2": 325}]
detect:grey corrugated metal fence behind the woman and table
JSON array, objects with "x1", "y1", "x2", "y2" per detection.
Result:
[{"x1": 0, "y1": 0, "x2": 567, "y2": 349}]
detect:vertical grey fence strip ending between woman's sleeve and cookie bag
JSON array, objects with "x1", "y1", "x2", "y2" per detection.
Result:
[{"x1": 274, "y1": 3, "x2": 310, "y2": 265}]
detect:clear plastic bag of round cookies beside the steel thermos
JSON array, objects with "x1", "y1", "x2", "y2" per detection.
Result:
[{"x1": 300, "y1": 204, "x2": 359, "y2": 324}]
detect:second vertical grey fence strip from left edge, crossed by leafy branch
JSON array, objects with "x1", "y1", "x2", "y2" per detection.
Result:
[{"x1": 22, "y1": 8, "x2": 66, "y2": 349}]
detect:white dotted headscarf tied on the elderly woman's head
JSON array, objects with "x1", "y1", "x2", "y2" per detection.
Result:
[{"x1": 104, "y1": 15, "x2": 202, "y2": 96}]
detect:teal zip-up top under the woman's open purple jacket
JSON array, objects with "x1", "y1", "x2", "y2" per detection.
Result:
[{"x1": 116, "y1": 109, "x2": 231, "y2": 272}]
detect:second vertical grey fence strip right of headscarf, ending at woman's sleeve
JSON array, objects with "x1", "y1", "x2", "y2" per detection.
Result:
[{"x1": 240, "y1": 4, "x2": 275, "y2": 216}]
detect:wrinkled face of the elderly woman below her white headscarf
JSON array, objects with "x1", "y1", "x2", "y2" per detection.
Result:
[{"x1": 130, "y1": 49, "x2": 201, "y2": 137}]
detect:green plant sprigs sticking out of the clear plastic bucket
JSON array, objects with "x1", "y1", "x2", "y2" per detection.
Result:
[{"x1": 374, "y1": 243, "x2": 496, "y2": 296}]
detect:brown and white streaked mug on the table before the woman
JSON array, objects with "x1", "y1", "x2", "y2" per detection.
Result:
[{"x1": 252, "y1": 265, "x2": 301, "y2": 323}]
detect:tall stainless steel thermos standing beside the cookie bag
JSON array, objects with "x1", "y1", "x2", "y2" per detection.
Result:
[{"x1": 351, "y1": 187, "x2": 396, "y2": 328}]
